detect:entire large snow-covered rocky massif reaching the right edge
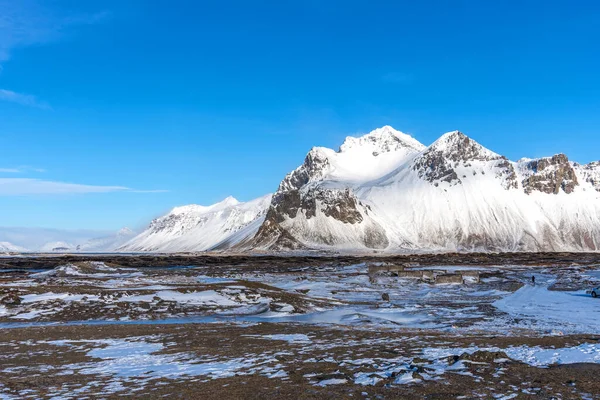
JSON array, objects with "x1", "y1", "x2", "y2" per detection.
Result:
[{"x1": 251, "y1": 126, "x2": 600, "y2": 251}]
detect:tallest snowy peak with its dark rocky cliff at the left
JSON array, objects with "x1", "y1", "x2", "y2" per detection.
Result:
[{"x1": 253, "y1": 126, "x2": 425, "y2": 249}]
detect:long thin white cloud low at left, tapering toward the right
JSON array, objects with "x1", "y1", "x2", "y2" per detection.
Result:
[{"x1": 0, "y1": 178, "x2": 166, "y2": 196}]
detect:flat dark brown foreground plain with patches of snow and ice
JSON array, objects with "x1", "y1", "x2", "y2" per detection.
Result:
[{"x1": 0, "y1": 261, "x2": 600, "y2": 399}]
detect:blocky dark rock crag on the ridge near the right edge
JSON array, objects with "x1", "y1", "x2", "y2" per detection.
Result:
[{"x1": 522, "y1": 154, "x2": 579, "y2": 194}]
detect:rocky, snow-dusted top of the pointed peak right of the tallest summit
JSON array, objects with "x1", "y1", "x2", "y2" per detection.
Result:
[{"x1": 413, "y1": 132, "x2": 518, "y2": 189}]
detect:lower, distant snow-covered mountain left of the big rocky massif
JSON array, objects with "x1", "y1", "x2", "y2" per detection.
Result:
[{"x1": 118, "y1": 195, "x2": 271, "y2": 252}]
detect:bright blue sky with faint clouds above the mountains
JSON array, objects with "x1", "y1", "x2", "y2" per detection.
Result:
[{"x1": 0, "y1": 0, "x2": 600, "y2": 230}]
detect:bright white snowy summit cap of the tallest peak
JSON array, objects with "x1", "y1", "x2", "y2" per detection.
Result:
[{"x1": 339, "y1": 125, "x2": 425, "y2": 156}]
